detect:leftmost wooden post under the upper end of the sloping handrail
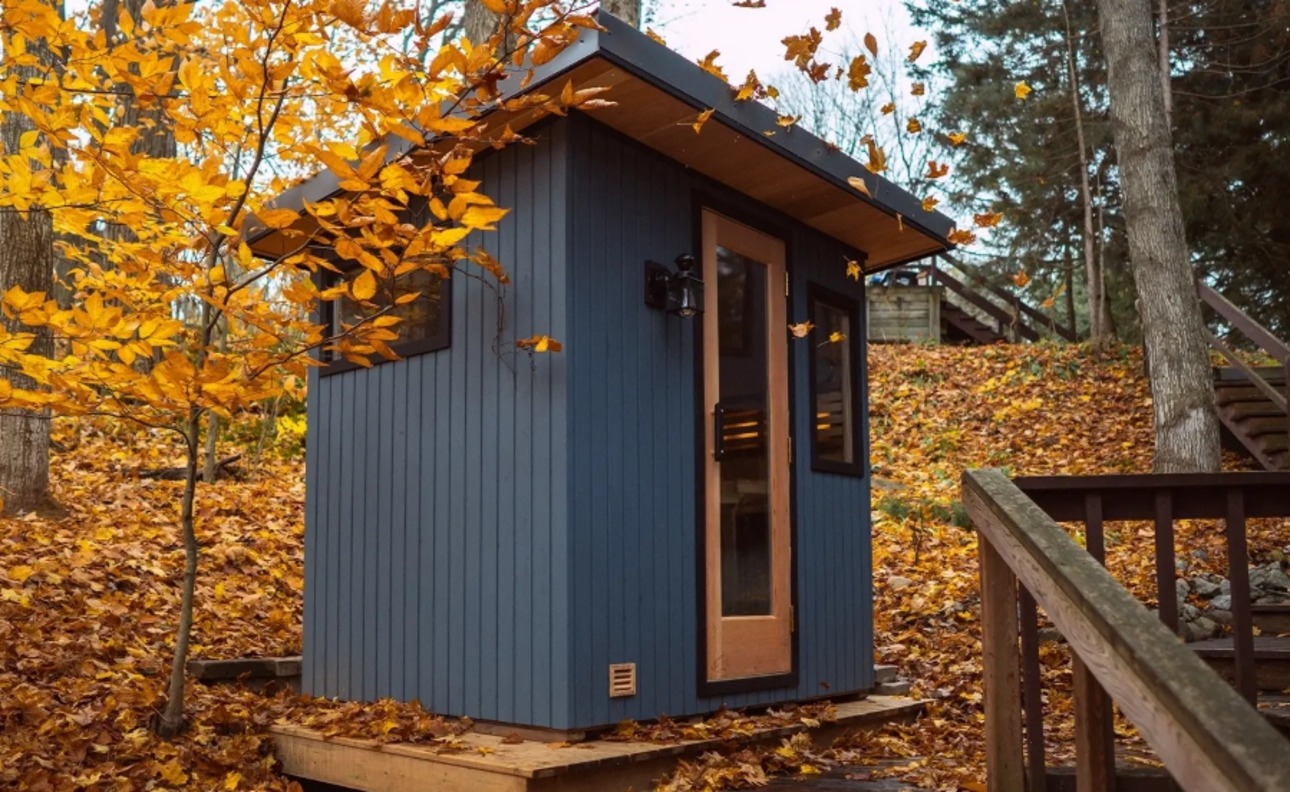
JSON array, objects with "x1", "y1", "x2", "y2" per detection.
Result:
[{"x1": 978, "y1": 534, "x2": 1026, "y2": 792}]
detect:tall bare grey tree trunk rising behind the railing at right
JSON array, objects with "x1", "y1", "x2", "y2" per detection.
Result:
[{"x1": 1098, "y1": 0, "x2": 1220, "y2": 473}]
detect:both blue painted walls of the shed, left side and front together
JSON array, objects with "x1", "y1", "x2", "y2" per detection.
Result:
[{"x1": 304, "y1": 115, "x2": 873, "y2": 728}]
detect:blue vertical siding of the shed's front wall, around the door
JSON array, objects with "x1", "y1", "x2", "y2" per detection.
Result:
[{"x1": 568, "y1": 116, "x2": 873, "y2": 726}]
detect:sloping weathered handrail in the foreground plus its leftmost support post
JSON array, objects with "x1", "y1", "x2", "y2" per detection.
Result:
[{"x1": 962, "y1": 471, "x2": 1290, "y2": 792}]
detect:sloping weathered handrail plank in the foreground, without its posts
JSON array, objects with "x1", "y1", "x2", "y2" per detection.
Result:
[{"x1": 964, "y1": 471, "x2": 1290, "y2": 792}]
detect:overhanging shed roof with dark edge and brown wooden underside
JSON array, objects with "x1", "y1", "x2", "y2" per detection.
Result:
[{"x1": 246, "y1": 13, "x2": 953, "y2": 272}]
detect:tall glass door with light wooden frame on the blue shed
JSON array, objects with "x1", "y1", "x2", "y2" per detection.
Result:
[{"x1": 703, "y1": 210, "x2": 792, "y2": 681}]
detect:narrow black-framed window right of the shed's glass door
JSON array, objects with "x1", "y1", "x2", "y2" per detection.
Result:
[{"x1": 808, "y1": 284, "x2": 864, "y2": 476}]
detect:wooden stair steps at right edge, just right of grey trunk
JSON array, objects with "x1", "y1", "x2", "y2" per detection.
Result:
[{"x1": 1214, "y1": 366, "x2": 1290, "y2": 471}]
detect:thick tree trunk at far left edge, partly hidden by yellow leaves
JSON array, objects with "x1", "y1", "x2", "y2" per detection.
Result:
[{"x1": 0, "y1": 48, "x2": 54, "y2": 515}]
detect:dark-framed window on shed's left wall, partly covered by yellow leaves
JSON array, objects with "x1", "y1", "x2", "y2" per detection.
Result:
[{"x1": 323, "y1": 270, "x2": 453, "y2": 374}]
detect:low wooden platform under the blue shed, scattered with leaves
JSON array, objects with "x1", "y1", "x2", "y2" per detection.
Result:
[{"x1": 272, "y1": 695, "x2": 924, "y2": 792}]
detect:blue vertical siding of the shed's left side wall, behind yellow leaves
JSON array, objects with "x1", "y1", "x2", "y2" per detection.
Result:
[{"x1": 304, "y1": 125, "x2": 570, "y2": 724}]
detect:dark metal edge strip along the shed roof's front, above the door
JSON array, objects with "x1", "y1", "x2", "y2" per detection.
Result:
[{"x1": 597, "y1": 12, "x2": 956, "y2": 248}]
